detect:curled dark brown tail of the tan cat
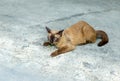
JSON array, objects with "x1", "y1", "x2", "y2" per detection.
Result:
[{"x1": 96, "y1": 30, "x2": 109, "y2": 46}]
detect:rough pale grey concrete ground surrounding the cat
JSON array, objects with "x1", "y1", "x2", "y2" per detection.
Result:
[{"x1": 0, "y1": 0, "x2": 120, "y2": 81}]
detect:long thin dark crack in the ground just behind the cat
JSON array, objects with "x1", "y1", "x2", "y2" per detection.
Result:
[{"x1": 45, "y1": 9, "x2": 113, "y2": 24}]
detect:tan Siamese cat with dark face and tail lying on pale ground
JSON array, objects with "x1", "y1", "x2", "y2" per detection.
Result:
[{"x1": 43, "y1": 21, "x2": 109, "y2": 57}]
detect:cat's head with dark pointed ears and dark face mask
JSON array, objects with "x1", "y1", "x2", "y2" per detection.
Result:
[{"x1": 46, "y1": 27, "x2": 64, "y2": 44}]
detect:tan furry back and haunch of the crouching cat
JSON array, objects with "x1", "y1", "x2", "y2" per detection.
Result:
[{"x1": 64, "y1": 21, "x2": 96, "y2": 45}]
